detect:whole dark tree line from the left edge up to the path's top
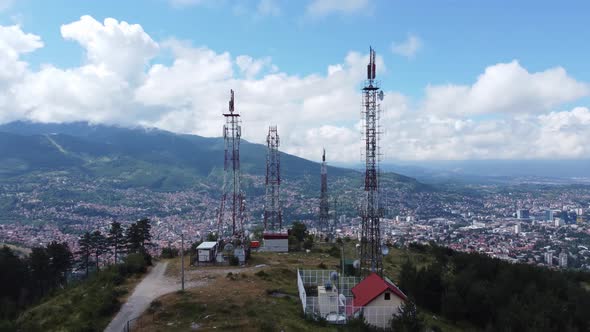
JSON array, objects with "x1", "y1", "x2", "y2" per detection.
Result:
[{"x1": 0, "y1": 218, "x2": 152, "y2": 324}]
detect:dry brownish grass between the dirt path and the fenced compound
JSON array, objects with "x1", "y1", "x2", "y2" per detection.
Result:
[{"x1": 134, "y1": 266, "x2": 338, "y2": 331}]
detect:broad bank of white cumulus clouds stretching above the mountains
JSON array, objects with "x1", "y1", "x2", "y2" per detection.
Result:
[{"x1": 0, "y1": 16, "x2": 590, "y2": 162}]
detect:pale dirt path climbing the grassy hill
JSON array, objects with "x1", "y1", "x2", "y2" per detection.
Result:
[{"x1": 105, "y1": 262, "x2": 180, "y2": 332}]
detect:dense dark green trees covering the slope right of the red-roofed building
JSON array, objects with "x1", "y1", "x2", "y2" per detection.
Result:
[{"x1": 400, "y1": 245, "x2": 590, "y2": 331}]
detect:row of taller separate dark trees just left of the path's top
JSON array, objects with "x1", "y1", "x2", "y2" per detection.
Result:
[{"x1": 77, "y1": 218, "x2": 152, "y2": 276}]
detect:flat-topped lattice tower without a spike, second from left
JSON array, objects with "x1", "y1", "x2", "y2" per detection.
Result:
[{"x1": 264, "y1": 126, "x2": 283, "y2": 232}]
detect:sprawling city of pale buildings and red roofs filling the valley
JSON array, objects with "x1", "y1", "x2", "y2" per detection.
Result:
[{"x1": 0, "y1": 167, "x2": 590, "y2": 270}]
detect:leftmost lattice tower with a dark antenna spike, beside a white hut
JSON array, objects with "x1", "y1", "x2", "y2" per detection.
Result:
[{"x1": 217, "y1": 90, "x2": 245, "y2": 240}]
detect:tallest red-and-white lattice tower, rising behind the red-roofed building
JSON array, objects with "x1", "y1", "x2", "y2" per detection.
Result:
[{"x1": 361, "y1": 48, "x2": 383, "y2": 275}]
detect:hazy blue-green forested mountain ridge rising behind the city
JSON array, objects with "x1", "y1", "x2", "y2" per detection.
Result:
[{"x1": 0, "y1": 121, "x2": 426, "y2": 190}]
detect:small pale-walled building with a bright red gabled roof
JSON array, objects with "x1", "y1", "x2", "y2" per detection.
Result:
[{"x1": 351, "y1": 272, "x2": 408, "y2": 328}]
